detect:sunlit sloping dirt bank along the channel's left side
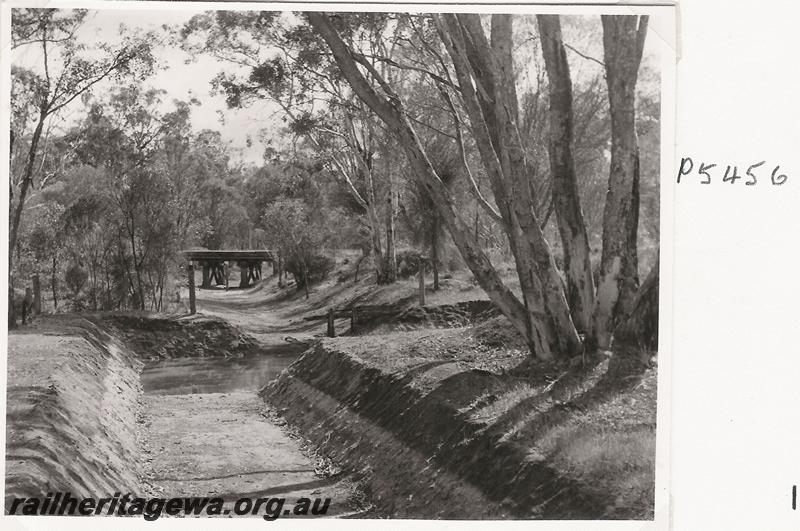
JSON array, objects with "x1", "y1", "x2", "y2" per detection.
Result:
[{"x1": 6, "y1": 316, "x2": 145, "y2": 507}]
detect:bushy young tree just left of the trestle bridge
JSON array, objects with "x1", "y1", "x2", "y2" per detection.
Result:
[{"x1": 71, "y1": 84, "x2": 194, "y2": 309}]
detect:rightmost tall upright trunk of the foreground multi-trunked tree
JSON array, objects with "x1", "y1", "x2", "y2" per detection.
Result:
[{"x1": 592, "y1": 15, "x2": 647, "y2": 349}]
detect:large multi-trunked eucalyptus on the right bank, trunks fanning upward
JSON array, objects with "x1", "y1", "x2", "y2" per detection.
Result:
[{"x1": 308, "y1": 13, "x2": 646, "y2": 359}]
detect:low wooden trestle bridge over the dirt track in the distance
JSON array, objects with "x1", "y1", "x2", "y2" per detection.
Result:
[{"x1": 181, "y1": 249, "x2": 275, "y2": 313}]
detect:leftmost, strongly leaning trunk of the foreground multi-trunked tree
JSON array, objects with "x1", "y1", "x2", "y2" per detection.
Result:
[{"x1": 308, "y1": 13, "x2": 580, "y2": 359}]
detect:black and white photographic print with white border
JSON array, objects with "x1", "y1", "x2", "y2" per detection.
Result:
[{"x1": 0, "y1": 1, "x2": 676, "y2": 529}]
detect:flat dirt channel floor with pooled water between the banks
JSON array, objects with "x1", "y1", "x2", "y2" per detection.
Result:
[{"x1": 134, "y1": 332, "x2": 351, "y2": 516}]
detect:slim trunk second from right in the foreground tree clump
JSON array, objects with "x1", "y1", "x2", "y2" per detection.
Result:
[{"x1": 536, "y1": 15, "x2": 594, "y2": 331}]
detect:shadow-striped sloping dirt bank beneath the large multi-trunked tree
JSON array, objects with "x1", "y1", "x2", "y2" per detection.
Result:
[{"x1": 261, "y1": 326, "x2": 655, "y2": 519}]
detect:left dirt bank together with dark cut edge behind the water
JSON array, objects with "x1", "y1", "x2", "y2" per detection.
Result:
[{"x1": 6, "y1": 314, "x2": 276, "y2": 507}]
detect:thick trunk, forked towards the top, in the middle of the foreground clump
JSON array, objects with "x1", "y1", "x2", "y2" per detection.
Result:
[{"x1": 440, "y1": 15, "x2": 581, "y2": 357}]
